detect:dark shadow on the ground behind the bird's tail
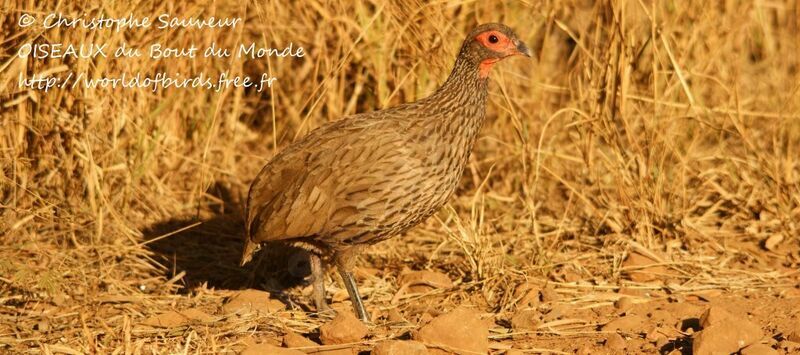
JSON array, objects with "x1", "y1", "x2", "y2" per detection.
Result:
[{"x1": 143, "y1": 183, "x2": 310, "y2": 293}]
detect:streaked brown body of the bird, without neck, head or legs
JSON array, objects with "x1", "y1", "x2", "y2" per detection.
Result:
[{"x1": 244, "y1": 104, "x2": 472, "y2": 259}]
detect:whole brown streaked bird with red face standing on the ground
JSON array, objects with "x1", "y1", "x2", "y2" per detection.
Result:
[{"x1": 241, "y1": 23, "x2": 531, "y2": 323}]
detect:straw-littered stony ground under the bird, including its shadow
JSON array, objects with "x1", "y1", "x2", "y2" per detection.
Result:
[{"x1": 0, "y1": 200, "x2": 800, "y2": 354}]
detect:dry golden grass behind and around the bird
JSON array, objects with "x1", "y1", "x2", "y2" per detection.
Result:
[{"x1": 0, "y1": 0, "x2": 800, "y2": 353}]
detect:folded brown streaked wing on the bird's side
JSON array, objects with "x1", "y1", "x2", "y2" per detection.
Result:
[{"x1": 246, "y1": 115, "x2": 421, "y2": 246}]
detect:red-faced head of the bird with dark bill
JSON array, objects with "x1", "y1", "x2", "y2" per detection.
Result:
[{"x1": 461, "y1": 23, "x2": 531, "y2": 78}]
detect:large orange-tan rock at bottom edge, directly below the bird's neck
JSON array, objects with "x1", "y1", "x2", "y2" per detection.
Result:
[{"x1": 414, "y1": 307, "x2": 489, "y2": 354}]
